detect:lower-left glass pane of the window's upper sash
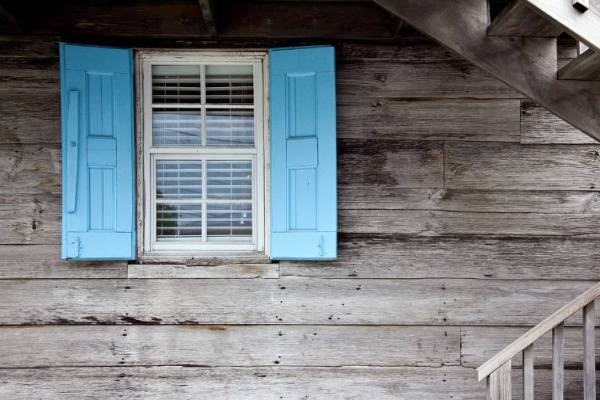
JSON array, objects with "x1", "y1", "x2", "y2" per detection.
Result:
[{"x1": 152, "y1": 109, "x2": 202, "y2": 146}]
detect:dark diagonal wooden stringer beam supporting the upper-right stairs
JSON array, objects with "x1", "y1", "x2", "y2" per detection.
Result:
[{"x1": 375, "y1": 0, "x2": 600, "y2": 139}]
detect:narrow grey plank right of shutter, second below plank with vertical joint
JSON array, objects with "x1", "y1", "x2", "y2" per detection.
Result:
[{"x1": 339, "y1": 209, "x2": 600, "y2": 238}]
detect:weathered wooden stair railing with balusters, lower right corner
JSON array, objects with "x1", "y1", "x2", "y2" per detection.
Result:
[{"x1": 477, "y1": 283, "x2": 600, "y2": 400}]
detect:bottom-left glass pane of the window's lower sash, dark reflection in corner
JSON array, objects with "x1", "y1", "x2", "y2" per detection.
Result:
[{"x1": 156, "y1": 203, "x2": 202, "y2": 239}]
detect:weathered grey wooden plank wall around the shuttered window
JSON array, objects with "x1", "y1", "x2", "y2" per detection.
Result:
[{"x1": 0, "y1": 35, "x2": 600, "y2": 400}]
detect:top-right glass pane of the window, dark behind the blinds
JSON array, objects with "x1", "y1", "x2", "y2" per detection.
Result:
[{"x1": 206, "y1": 65, "x2": 254, "y2": 104}]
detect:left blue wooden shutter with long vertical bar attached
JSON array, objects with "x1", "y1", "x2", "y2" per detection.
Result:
[{"x1": 60, "y1": 43, "x2": 135, "y2": 260}]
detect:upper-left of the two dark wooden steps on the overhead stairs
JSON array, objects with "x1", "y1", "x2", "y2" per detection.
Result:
[{"x1": 488, "y1": 0, "x2": 563, "y2": 37}]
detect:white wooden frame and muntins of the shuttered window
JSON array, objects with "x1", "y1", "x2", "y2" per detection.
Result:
[{"x1": 136, "y1": 50, "x2": 268, "y2": 258}]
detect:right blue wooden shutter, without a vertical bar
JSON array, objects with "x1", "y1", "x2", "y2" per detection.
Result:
[{"x1": 269, "y1": 46, "x2": 337, "y2": 260}]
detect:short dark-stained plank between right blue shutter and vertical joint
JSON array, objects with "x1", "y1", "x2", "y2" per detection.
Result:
[{"x1": 338, "y1": 139, "x2": 444, "y2": 188}]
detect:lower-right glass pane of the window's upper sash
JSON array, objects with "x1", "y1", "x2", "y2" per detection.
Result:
[{"x1": 206, "y1": 108, "x2": 254, "y2": 146}]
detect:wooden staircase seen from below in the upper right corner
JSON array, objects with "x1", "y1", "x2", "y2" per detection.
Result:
[{"x1": 374, "y1": 0, "x2": 600, "y2": 140}]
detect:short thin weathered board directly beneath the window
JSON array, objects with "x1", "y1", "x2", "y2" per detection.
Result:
[{"x1": 127, "y1": 260, "x2": 279, "y2": 279}]
